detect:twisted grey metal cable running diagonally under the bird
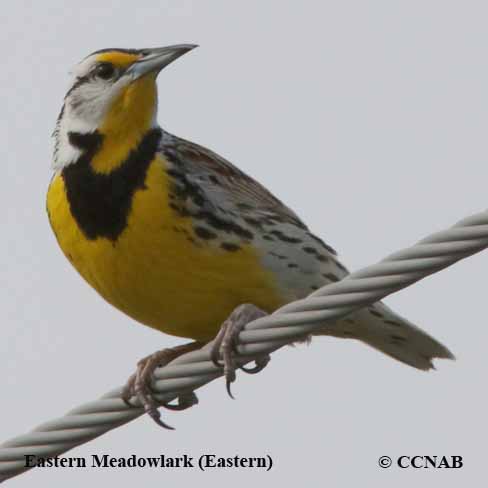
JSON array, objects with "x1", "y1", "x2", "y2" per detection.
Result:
[{"x1": 0, "y1": 211, "x2": 488, "y2": 482}]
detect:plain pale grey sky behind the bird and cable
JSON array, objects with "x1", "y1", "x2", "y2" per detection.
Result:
[{"x1": 0, "y1": 0, "x2": 488, "y2": 488}]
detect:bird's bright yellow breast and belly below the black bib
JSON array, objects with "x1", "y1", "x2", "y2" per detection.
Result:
[{"x1": 47, "y1": 155, "x2": 284, "y2": 341}]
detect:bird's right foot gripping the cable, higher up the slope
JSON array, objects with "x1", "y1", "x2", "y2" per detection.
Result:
[{"x1": 210, "y1": 303, "x2": 270, "y2": 398}]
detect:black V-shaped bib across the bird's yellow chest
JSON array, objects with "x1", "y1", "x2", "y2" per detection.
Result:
[{"x1": 62, "y1": 129, "x2": 161, "y2": 242}]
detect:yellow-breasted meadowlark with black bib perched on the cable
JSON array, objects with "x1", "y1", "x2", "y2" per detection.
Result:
[{"x1": 47, "y1": 44, "x2": 454, "y2": 427}]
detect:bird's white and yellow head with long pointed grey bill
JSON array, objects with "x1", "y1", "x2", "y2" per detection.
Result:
[{"x1": 54, "y1": 44, "x2": 196, "y2": 172}]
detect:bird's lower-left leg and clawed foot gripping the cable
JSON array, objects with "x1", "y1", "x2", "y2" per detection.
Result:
[{"x1": 121, "y1": 342, "x2": 203, "y2": 429}]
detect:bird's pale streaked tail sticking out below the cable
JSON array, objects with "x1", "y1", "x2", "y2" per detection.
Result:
[{"x1": 323, "y1": 302, "x2": 455, "y2": 370}]
